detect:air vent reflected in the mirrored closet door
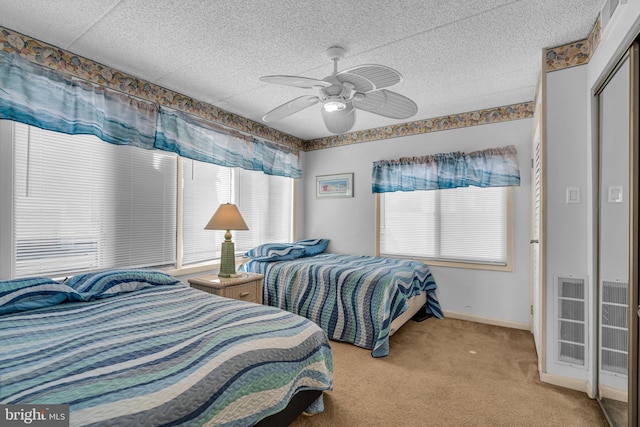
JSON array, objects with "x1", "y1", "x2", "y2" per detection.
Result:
[{"x1": 600, "y1": 280, "x2": 629, "y2": 375}]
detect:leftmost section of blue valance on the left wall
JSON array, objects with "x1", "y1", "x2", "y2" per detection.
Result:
[{"x1": 0, "y1": 51, "x2": 157, "y2": 149}]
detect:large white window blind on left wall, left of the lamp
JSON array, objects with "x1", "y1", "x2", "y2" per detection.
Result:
[{"x1": 14, "y1": 123, "x2": 177, "y2": 277}]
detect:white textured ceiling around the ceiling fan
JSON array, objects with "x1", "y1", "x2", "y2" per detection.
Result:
[{"x1": 0, "y1": 0, "x2": 603, "y2": 140}]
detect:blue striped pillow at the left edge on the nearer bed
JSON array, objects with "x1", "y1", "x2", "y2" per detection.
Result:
[{"x1": 0, "y1": 277, "x2": 81, "y2": 314}]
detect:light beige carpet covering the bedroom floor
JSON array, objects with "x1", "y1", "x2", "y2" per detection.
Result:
[{"x1": 291, "y1": 318, "x2": 608, "y2": 427}]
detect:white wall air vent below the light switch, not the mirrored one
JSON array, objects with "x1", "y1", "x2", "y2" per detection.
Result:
[{"x1": 555, "y1": 277, "x2": 587, "y2": 366}]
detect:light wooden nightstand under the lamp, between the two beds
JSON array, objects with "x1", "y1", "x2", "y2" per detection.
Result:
[{"x1": 188, "y1": 273, "x2": 264, "y2": 304}]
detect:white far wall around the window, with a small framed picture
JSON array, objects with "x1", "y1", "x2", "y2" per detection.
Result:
[{"x1": 301, "y1": 119, "x2": 533, "y2": 328}]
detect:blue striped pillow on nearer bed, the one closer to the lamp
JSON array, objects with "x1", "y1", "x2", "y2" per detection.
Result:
[{"x1": 64, "y1": 269, "x2": 180, "y2": 301}]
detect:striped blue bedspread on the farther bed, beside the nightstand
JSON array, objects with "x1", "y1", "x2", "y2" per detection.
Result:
[{"x1": 240, "y1": 253, "x2": 442, "y2": 357}]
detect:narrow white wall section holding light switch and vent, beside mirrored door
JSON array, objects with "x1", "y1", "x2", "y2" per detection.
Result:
[{"x1": 545, "y1": 65, "x2": 596, "y2": 380}]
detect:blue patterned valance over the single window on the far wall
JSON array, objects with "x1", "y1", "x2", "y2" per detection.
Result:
[{"x1": 371, "y1": 145, "x2": 520, "y2": 193}]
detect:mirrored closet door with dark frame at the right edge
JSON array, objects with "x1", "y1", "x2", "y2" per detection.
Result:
[{"x1": 597, "y1": 45, "x2": 638, "y2": 426}]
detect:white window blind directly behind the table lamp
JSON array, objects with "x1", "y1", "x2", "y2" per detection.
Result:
[{"x1": 182, "y1": 160, "x2": 293, "y2": 265}]
